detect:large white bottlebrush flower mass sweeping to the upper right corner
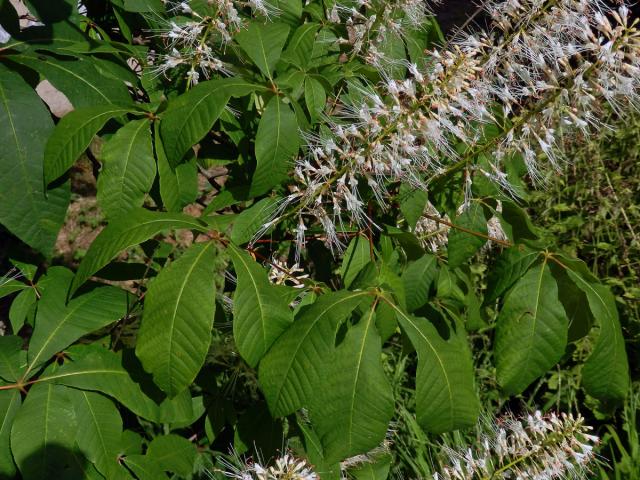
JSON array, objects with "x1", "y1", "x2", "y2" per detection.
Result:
[{"x1": 288, "y1": 0, "x2": 640, "y2": 255}]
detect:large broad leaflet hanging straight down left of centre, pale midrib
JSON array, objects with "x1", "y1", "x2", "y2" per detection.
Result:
[{"x1": 136, "y1": 241, "x2": 217, "y2": 397}]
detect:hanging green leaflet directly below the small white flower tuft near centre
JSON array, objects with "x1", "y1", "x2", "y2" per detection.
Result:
[{"x1": 228, "y1": 245, "x2": 292, "y2": 367}]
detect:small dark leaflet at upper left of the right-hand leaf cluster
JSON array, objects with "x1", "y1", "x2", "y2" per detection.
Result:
[{"x1": 484, "y1": 245, "x2": 540, "y2": 303}]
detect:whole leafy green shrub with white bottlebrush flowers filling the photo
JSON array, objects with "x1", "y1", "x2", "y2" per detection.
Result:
[{"x1": 0, "y1": 0, "x2": 640, "y2": 479}]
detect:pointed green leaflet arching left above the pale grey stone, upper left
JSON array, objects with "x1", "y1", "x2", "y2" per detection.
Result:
[{"x1": 7, "y1": 55, "x2": 131, "y2": 108}]
